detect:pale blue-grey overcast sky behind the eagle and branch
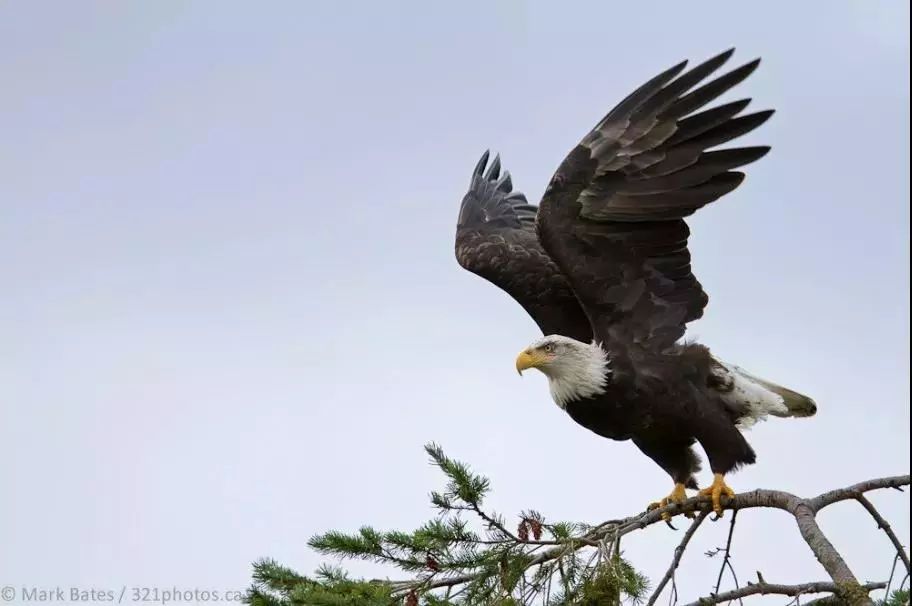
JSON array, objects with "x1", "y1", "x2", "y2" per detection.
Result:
[{"x1": 0, "y1": 0, "x2": 910, "y2": 603}]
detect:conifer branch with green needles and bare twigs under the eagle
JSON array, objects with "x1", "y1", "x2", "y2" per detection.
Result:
[{"x1": 248, "y1": 444, "x2": 910, "y2": 606}]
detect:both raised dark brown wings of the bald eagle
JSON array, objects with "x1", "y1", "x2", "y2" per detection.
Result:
[{"x1": 456, "y1": 50, "x2": 772, "y2": 360}]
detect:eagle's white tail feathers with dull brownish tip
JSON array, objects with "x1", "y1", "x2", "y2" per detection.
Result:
[{"x1": 713, "y1": 362, "x2": 817, "y2": 429}]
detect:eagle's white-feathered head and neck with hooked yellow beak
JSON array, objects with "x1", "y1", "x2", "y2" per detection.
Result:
[{"x1": 516, "y1": 335, "x2": 611, "y2": 408}]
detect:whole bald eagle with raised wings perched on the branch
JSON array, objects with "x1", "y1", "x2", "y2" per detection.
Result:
[{"x1": 456, "y1": 49, "x2": 817, "y2": 515}]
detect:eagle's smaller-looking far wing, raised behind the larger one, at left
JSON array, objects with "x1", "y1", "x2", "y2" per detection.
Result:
[{"x1": 456, "y1": 152, "x2": 592, "y2": 342}]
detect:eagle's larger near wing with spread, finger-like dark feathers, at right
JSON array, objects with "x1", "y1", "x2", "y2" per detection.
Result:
[{"x1": 538, "y1": 49, "x2": 772, "y2": 356}]
